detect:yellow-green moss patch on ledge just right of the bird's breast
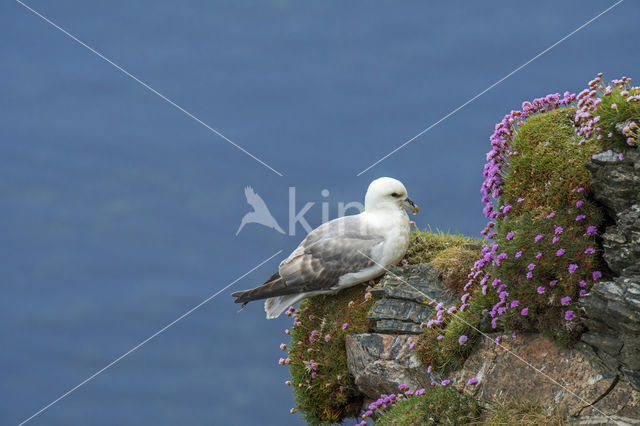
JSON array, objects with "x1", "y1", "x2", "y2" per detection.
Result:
[{"x1": 404, "y1": 227, "x2": 481, "y2": 265}]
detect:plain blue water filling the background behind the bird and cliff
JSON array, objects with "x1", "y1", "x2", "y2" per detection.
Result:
[{"x1": 0, "y1": 0, "x2": 640, "y2": 425}]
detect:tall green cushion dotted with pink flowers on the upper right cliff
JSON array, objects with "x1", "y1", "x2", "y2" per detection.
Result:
[{"x1": 491, "y1": 108, "x2": 602, "y2": 344}]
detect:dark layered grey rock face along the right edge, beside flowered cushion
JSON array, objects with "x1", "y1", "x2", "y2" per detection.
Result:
[{"x1": 579, "y1": 148, "x2": 640, "y2": 398}]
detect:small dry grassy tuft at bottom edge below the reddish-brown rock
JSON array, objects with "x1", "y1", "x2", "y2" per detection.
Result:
[{"x1": 482, "y1": 400, "x2": 569, "y2": 426}]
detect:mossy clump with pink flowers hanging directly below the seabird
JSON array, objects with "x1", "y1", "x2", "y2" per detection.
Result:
[{"x1": 289, "y1": 285, "x2": 373, "y2": 424}]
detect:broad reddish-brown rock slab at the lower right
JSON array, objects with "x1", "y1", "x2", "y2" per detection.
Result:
[{"x1": 451, "y1": 334, "x2": 640, "y2": 419}]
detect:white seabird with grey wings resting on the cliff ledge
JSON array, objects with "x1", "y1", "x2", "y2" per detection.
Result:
[{"x1": 231, "y1": 177, "x2": 418, "y2": 319}]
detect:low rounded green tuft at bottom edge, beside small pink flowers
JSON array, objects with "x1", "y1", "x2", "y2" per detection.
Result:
[{"x1": 375, "y1": 386, "x2": 480, "y2": 426}]
